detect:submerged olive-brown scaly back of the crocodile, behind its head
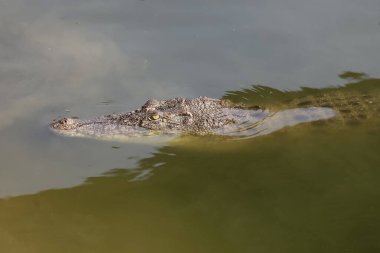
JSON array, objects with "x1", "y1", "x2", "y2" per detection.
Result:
[{"x1": 223, "y1": 75, "x2": 380, "y2": 125}]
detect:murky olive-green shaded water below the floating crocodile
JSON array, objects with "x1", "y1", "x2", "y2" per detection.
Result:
[{"x1": 0, "y1": 76, "x2": 380, "y2": 253}]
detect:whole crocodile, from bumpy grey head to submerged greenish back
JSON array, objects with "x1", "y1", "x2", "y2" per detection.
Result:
[{"x1": 50, "y1": 77, "x2": 379, "y2": 139}]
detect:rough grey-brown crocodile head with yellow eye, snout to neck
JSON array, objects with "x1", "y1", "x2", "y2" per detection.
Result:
[{"x1": 50, "y1": 97, "x2": 249, "y2": 136}]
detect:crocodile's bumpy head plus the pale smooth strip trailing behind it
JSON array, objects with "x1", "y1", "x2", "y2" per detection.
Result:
[{"x1": 50, "y1": 97, "x2": 336, "y2": 139}]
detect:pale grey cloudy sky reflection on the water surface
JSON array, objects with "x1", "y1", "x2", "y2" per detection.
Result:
[{"x1": 0, "y1": 0, "x2": 380, "y2": 200}]
